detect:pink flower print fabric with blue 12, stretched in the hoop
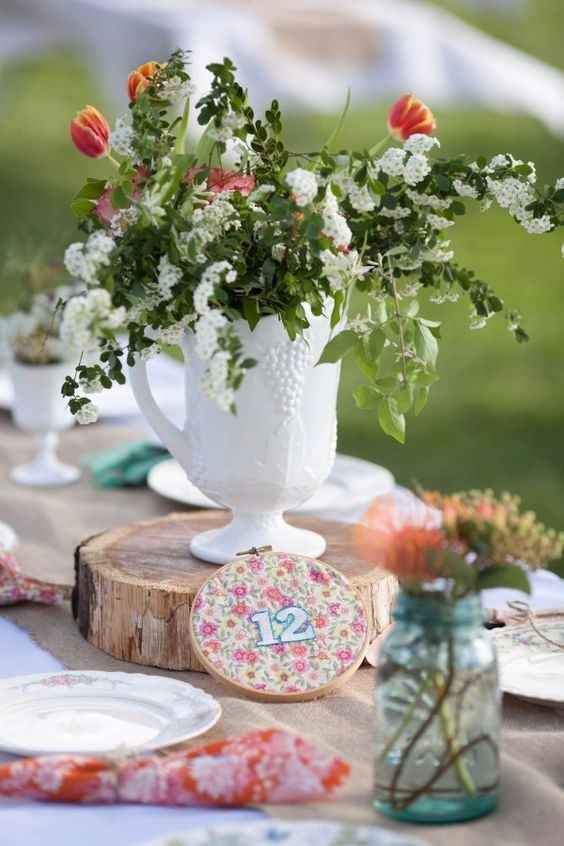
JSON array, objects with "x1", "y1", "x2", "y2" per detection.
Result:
[{"x1": 191, "y1": 552, "x2": 367, "y2": 699}]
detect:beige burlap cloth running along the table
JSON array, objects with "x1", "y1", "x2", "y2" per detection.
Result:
[{"x1": 0, "y1": 414, "x2": 564, "y2": 846}]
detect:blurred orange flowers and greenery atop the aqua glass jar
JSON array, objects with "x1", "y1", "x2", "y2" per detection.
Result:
[{"x1": 356, "y1": 490, "x2": 564, "y2": 600}]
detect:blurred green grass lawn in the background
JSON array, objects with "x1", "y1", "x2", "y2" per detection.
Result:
[{"x1": 0, "y1": 0, "x2": 564, "y2": 529}]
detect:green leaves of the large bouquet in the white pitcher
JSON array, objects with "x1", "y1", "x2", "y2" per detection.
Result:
[{"x1": 4, "y1": 44, "x2": 561, "y2": 450}]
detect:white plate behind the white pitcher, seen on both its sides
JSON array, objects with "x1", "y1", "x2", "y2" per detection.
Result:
[{"x1": 147, "y1": 455, "x2": 394, "y2": 514}]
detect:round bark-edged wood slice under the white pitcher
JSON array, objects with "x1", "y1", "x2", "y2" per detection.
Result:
[{"x1": 73, "y1": 510, "x2": 397, "y2": 671}]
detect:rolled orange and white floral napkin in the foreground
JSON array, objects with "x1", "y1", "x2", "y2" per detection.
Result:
[{"x1": 0, "y1": 729, "x2": 350, "y2": 807}]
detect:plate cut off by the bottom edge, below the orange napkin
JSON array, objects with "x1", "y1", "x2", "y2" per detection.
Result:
[{"x1": 143, "y1": 820, "x2": 428, "y2": 846}]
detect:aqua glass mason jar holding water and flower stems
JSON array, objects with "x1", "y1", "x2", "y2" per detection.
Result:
[{"x1": 374, "y1": 592, "x2": 501, "y2": 823}]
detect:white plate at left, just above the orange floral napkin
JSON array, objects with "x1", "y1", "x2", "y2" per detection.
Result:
[{"x1": 0, "y1": 671, "x2": 221, "y2": 755}]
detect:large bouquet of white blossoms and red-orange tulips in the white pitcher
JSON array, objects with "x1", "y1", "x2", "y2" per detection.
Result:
[{"x1": 63, "y1": 52, "x2": 564, "y2": 434}]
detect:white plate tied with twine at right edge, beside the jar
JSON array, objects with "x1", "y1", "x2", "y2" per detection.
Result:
[{"x1": 493, "y1": 612, "x2": 564, "y2": 706}]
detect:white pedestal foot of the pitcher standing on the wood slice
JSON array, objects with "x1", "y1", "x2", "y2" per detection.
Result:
[{"x1": 190, "y1": 514, "x2": 327, "y2": 564}]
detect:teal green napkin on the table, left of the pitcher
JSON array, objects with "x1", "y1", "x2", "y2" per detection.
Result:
[{"x1": 82, "y1": 441, "x2": 170, "y2": 488}]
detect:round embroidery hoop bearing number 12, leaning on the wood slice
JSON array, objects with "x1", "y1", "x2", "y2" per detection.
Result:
[{"x1": 190, "y1": 550, "x2": 369, "y2": 702}]
